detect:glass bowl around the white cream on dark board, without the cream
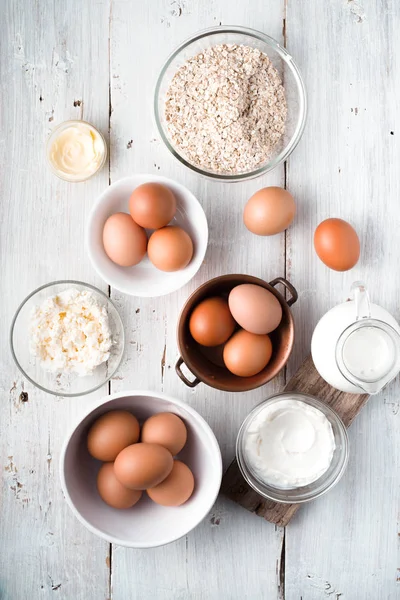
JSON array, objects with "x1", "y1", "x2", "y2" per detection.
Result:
[{"x1": 236, "y1": 392, "x2": 349, "y2": 504}]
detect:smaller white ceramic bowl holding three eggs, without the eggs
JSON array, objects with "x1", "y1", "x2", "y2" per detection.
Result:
[{"x1": 86, "y1": 175, "x2": 208, "y2": 298}]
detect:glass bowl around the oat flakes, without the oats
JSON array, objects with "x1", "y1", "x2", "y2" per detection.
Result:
[{"x1": 154, "y1": 27, "x2": 307, "y2": 181}]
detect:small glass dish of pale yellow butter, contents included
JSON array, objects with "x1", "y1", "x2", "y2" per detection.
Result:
[{"x1": 46, "y1": 121, "x2": 107, "y2": 182}]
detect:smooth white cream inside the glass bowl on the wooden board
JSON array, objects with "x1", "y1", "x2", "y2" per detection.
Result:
[{"x1": 243, "y1": 398, "x2": 335, "y2": 489}]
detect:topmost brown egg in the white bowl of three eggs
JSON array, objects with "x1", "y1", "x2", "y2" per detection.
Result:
[{"x1": 129, "y1": 183, "x2": 176, "y2": 229}]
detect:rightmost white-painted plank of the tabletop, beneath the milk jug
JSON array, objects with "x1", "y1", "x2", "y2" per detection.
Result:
[{"x1": 286, "y1": 0, "x2": 400, "y2": 600}]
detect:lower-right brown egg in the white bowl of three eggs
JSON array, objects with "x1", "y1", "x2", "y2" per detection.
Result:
[{"x1": 147, "y1": 226, "x2": 193, "y2": 271}]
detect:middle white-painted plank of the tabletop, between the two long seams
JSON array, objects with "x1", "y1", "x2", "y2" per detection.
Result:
[{"x1": 111, "y1": 0, "x2": 284, "y2": 600}]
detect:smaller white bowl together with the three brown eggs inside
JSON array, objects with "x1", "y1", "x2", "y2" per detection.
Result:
[{"x1": 86, "y1": 175, "x2": 208, "y2": 297}]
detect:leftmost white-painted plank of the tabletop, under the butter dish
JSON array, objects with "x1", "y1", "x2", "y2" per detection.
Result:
[{"x1": 0, "y1": 0, "x2": 109, "y2": 600}]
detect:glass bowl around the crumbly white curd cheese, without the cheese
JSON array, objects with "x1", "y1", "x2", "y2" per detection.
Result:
[{"x1": 10, "y1": 280, "x2": 125, "y2": 397}]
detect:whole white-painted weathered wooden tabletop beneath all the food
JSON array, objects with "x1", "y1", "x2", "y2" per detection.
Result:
[{"x1": 0, "y1": 0, "x2": 400, "y2": 600}]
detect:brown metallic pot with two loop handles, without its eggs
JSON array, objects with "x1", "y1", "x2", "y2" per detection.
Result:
[{"x1": 175, "y1": 275, "x2": 298, "y2": 392}]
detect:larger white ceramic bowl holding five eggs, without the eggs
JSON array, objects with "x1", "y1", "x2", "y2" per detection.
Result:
[{"x1": 60, "y1": 391, "x2": 222, "y2": 548}]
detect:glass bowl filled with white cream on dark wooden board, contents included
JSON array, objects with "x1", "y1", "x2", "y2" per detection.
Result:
[{"x1": 236, "y1": 392, "x2": 349, "y2": 504}]
